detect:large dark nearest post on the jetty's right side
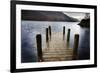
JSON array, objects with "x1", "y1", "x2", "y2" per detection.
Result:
[{"x1": 73, "y1": 34, "x2": 79, "y2": 60}]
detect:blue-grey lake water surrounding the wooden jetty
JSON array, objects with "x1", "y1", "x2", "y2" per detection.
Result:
[{"x1": 21, "y1": 21, "x2": 90, "y2": 63}]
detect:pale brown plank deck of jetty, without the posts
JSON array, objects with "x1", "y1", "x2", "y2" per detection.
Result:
[{"x1": 43, "y1": 32, "x2": 73, "y2": 61}]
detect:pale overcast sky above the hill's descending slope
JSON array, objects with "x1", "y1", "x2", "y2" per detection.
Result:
[{"x1": 64, "y1": 12, "x2": 89, "y2": 20}]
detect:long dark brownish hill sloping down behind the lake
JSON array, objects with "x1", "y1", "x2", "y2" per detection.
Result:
[{"x1": 21, "y1": 10, "x2": 78, "y2": 22}]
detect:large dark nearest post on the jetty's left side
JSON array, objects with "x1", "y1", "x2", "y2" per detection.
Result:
[{"x1": 36, "y1": 34, "x2": 43, "y2": 62}]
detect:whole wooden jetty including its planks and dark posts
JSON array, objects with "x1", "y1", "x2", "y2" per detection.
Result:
[{"x1": 37, "y1": 27, "x2": 79, "y2": 62}]
